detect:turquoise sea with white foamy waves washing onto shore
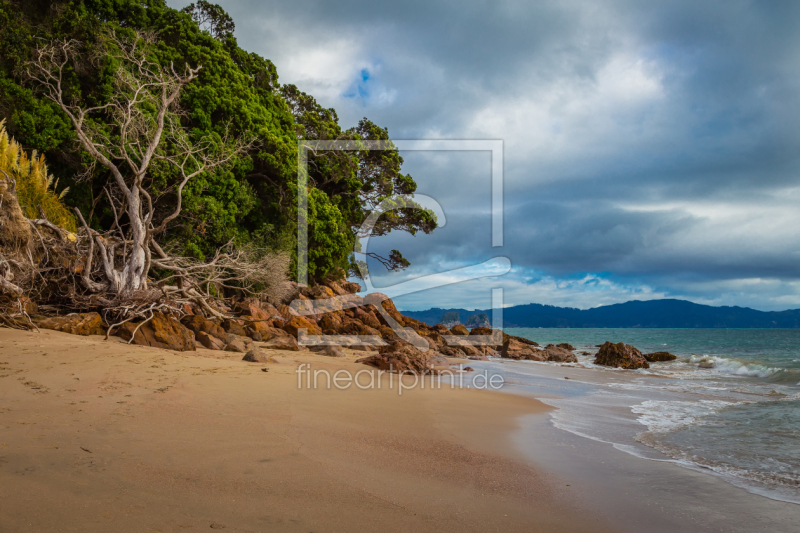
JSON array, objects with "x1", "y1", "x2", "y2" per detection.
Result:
[{"x1": 490, "y1": 328, "x2": 800, "y2": 503}]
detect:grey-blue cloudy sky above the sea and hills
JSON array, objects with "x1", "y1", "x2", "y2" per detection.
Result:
[{"x1": 170, "y1": 0, "x2": 800, "y2": 310}]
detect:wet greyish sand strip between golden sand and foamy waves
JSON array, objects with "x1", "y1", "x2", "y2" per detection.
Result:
[{"x1": 489, "y1": 362, "x2": 800, "y2": 533}]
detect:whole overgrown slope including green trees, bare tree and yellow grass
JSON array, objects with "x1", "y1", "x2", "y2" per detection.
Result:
[{"x1": 0, "y1": 0, "x2": 436, "y2": 320}]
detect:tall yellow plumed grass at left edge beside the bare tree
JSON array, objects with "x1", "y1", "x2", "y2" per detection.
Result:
[{"x1": 0, "y1": 120, "x2": 76, "y2": 232}]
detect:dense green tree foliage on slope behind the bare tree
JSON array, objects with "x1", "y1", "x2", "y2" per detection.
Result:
[{"x1": 0, "y1": 0, "x2": 436, "y2": 279}]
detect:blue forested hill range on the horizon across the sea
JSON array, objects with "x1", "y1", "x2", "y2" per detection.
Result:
[{"x1": 402, "y1": 299, "x2": 800, "y2": 328}]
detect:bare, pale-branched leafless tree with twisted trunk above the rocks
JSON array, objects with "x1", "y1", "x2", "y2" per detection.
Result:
[{"x1": 27, "y1": 32, "x2": 254, "y2": 294}]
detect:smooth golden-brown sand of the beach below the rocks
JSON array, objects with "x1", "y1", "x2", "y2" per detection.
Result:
[{"x1": 0, "y1": 329, "x2": 611, "y2": 532}]
